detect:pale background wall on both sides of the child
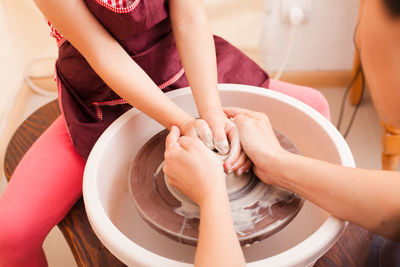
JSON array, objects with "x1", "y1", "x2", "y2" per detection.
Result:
[{"x1": 0, "y1": 0, "x2": 359, "y2": 132}]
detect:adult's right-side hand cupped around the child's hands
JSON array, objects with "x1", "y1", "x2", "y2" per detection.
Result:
[{"x1": 224, "y1": 108, "x2": 286, "y2": 183}]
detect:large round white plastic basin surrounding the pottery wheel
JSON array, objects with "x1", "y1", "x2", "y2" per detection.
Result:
[{"x1": 83, "y1": 84, "x2": 354, "y2": 267}]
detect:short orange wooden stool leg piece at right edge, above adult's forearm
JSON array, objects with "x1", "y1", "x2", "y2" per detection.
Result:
[{"x1": 382, "y1": 129, "x2": 400, "y2": 170}]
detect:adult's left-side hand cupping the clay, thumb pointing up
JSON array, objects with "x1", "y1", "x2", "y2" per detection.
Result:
[{"x1": 163, "y1": 126, "x2": 226, "y2": 207}]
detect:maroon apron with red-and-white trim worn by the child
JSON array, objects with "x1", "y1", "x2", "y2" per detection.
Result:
[{"x1": 56, "y1": 0, "x2": 269, "y2": 159}]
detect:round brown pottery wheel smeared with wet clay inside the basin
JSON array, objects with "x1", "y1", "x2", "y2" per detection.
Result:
[{"x1": 129, "y1": 130, "x2": 303, "y2": 245}]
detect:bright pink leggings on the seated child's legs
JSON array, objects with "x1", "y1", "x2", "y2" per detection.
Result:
[{"x1": 0, "y1": 80, "x2": 330, "y2": 267}]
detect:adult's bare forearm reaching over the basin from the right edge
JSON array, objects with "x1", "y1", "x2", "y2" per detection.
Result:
[{"x1": 266, "y1": 153, "x2": 400, "y2": 240}]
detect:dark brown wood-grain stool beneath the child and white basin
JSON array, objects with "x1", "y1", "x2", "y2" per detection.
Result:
[{"x1": 4, "y1": 100, "x2": 372, "y2": 267}]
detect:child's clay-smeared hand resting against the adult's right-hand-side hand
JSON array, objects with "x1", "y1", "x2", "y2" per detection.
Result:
[{"x1": 202, "y1": 110, "x2": 251, "y2": 175}]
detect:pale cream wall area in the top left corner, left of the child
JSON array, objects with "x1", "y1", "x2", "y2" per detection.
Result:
[{"x1": 0, "y1": 0, "x2": 57, "y2": 134}]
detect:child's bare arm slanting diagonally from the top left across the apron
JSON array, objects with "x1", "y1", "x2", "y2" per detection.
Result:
[{"x1": 35, "y1": 0, "x2": 192, "y2": 129}]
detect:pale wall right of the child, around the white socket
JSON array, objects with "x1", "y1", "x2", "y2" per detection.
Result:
[{"x1": 204, "y1": 0, "x2": 359, "y2": 71}]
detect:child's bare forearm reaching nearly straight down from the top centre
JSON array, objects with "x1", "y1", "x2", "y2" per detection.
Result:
[{"x1": 170, "y1": 0, "x2": 222, "y2": 116}]
